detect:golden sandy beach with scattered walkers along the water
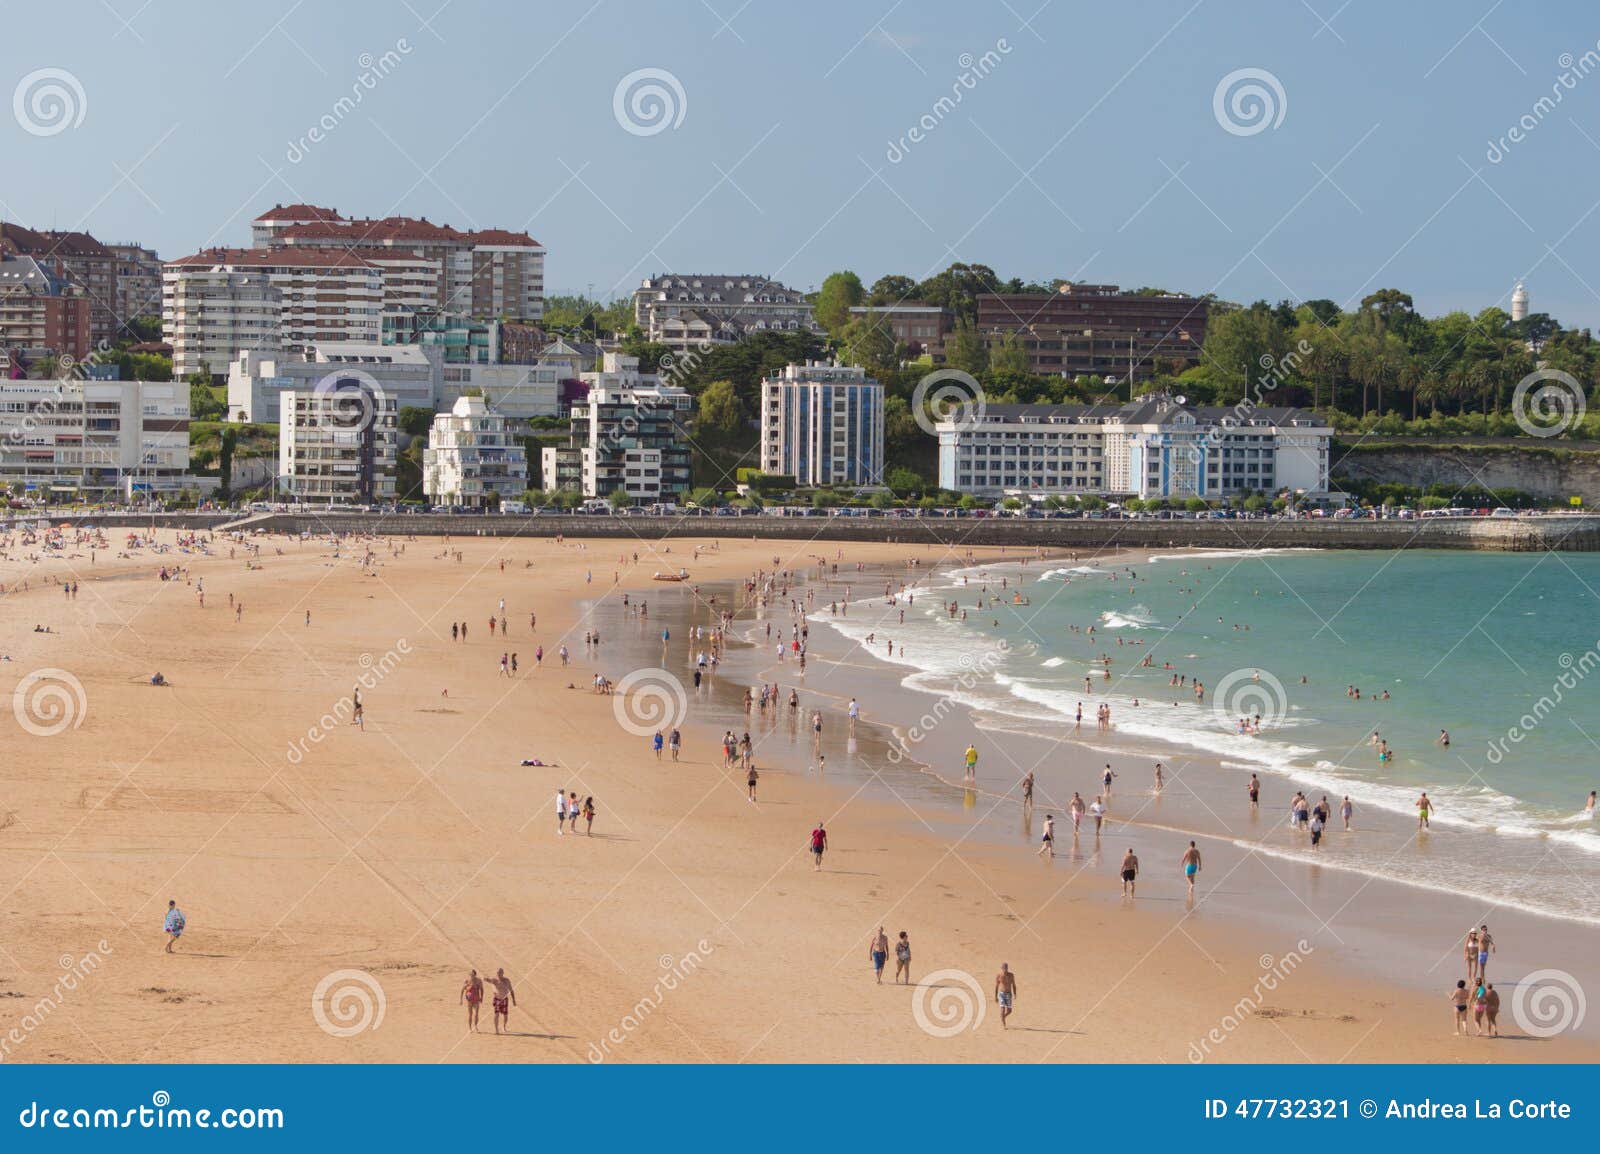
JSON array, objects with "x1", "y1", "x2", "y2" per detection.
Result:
[{"x1": 0, "y1": 525, "x2": 1600, "y2": 1063}]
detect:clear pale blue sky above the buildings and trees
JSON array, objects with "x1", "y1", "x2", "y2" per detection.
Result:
[{"x1": 0, "y1": 0, "x2": 1600, "y2": 327}]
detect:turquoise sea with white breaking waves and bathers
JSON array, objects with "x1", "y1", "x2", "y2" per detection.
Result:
[{"x1": 813, "y1": 551, "x2": 1600, "y2": 924}]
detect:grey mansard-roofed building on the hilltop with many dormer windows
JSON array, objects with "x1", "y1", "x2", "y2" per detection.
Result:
[{"x1": 634, "y1": 274, "x2": 821, "y2": 351}]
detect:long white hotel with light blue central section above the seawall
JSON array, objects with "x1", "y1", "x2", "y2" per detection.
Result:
[{"x1": 938, "y1": 394, "x2": 1333, "y2": 499}]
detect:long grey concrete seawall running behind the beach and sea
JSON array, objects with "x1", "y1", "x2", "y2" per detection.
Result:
[{"x1": 168, "y1": 514, "x2": 1600, "y2": 552}]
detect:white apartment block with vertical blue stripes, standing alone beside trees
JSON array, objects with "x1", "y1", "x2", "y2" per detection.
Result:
[{"x1": 760, "y1": 362, "x2": 883, "y2": 485}]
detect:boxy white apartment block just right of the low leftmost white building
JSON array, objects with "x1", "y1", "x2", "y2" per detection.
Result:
[{"x1": 278, "y1": 380, "x2": 400, "y2": 504}]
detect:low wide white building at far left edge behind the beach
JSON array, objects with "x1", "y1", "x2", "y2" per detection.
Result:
[{"x1": 0, "y1": 378, "x2": 197, "y2": 501}]
